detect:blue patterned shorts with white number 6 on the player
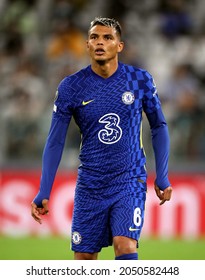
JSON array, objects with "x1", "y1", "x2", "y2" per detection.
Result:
[{"x1": 71, "y1": 182, "x2": 147, "y2": 253}]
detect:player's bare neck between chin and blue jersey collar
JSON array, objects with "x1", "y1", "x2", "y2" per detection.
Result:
[{"x1": 91, "y1": 60, "x2": 118, "y2": 79}]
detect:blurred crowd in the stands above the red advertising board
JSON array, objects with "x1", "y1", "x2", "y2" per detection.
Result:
[{"x1": 0, "y1": 0, "x2": 205, "y2": 169}]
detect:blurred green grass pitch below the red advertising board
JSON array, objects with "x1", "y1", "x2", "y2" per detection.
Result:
[{"x1": 0, "y1": 236, "x2": 205, "y2": 260}]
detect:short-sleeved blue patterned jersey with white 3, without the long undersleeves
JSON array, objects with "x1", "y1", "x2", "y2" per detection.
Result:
[{"x1": 53, "y1": 63, "x2": 160, "y2": 188}]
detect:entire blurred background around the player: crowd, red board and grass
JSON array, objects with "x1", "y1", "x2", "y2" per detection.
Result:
[{"x1": 0, "y1": 0, "x2": 205, "y2": 259}]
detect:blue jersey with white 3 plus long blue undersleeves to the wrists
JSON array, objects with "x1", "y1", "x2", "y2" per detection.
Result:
[{"x1": 34, "y1": 63, "x2": 170, "y2": 206}]
